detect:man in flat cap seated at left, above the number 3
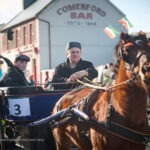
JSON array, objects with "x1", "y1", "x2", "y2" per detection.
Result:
[{"x1": 4, "y1": 54, "x2": 30, "y2": 87}]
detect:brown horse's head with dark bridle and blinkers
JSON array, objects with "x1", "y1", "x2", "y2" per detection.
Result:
[{"x1": 115, "y1": 31, "x2": 150, "y2": 89}]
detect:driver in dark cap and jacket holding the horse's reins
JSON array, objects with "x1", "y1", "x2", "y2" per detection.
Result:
[{"x1": 52, "y1": 42, "x2": 98, "y2": 89}]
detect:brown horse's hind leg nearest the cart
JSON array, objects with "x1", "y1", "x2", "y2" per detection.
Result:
[{"x1": 53, "y1": 128, "x2": 73, "y2": 150}]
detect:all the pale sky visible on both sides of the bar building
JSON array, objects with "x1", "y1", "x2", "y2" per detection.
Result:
[{"x1": 0, "y1": 0, "x2": 150, "y2": 32}]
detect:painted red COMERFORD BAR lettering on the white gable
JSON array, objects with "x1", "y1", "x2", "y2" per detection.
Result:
[{"x1": 56, "y1": 3, "x2": 107, "y2": 26}]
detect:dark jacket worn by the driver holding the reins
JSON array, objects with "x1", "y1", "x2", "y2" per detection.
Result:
[{"x1": 52, "y1": 59, "x2": 98, "y2": 89}]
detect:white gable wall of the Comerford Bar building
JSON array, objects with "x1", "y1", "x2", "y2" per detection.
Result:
[{"x1": 39, "y1": 0, "x2": 124, "y2": 69}]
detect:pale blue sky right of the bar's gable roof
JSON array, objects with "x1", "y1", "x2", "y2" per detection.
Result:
[{"x1": 110, "y1": 0, "x2": 150, "y2": 32}]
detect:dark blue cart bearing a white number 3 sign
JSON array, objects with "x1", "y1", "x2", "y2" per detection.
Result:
[{"x1": 0, "y1": 86, "x2": 66, "y2": 150}]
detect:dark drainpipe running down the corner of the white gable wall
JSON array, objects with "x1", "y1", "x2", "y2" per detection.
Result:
[{"x1": 37, "y1": 17, "x2": 52, "y2": 69}]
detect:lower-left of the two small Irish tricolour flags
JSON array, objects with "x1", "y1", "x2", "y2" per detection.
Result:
[{"x1": 104, "y1": 25, "x2": 119, "y2": 39}]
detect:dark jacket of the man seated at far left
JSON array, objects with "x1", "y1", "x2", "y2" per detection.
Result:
[{"x1": 0, "y1": 67, "x2": 29, "y2": 87}]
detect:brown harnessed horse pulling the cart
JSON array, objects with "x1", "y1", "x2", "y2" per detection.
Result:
[{"x1": 53, "y1": 32, "x2": 150, "y2": 150}]
